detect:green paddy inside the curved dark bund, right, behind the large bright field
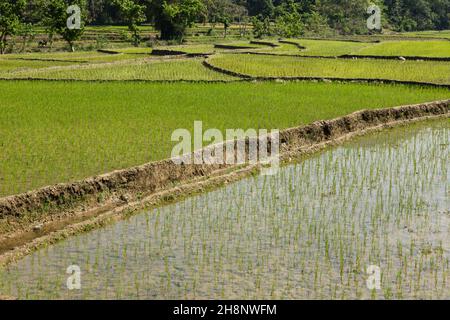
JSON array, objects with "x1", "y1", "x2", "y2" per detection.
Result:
[{"x1": 210, "y1": 54, "x2": 450, "y2": 84}]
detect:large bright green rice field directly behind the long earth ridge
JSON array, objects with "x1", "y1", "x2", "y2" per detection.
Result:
[{"x1": 0, "y1": 81, "x2": 450, "y2": 196}]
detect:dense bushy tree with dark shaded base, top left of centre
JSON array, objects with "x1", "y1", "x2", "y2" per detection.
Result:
[{"x1": 151, "y1": 0, "x2": 206, "y2": 41}]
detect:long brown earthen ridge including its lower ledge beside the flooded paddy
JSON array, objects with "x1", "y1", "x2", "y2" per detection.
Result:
[{"x1": 0, "y1": 100, "x2": 450, "y2": 265}]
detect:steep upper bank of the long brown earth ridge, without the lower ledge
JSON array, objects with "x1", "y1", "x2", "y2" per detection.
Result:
[{"x1": 0, "y1": 100, "x2": 450, "y2": 225}]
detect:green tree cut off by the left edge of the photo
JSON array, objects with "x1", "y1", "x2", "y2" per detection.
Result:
[{"x1": 0, "y1": 0, "x2": 26, "y2": 54}]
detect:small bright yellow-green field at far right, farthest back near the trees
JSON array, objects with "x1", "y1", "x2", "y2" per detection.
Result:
[{"x1": 355, "y1": 41, "x2": 450, "y2": 57}]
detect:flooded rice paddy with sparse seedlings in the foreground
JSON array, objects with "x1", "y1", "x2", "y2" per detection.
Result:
[{"x1": 0, "y1": 119, "x2": 450, "y2": 299}]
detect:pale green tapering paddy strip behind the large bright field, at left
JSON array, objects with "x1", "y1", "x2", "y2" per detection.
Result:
[{"x1": 2, "y1": 59, "x2": 235, "y2": 80}]
